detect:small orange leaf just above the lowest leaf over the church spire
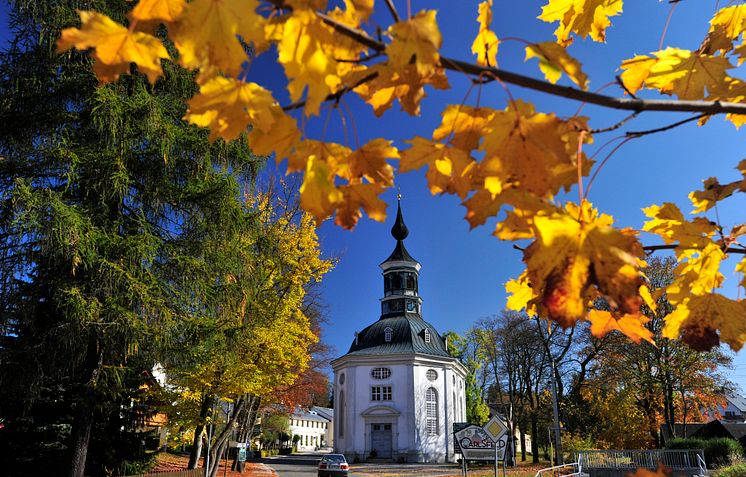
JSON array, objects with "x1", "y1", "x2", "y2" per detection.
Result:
[{"x1": 333, "y1": 138, "x2": 399, "y2": 187}]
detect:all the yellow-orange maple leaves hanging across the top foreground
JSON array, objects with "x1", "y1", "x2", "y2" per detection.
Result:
[{"x1": 59, "y1": 0, "x2": 746, "y2": 349}]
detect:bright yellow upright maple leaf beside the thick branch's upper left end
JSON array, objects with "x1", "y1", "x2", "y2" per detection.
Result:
[{"x1": 277, "y1": 10, "x2": 342, "y2": 115}]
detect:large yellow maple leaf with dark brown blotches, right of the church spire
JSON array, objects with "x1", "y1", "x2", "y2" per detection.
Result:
[{"x1": 524, "y1": 202, "x2": 643, "y2": 327}]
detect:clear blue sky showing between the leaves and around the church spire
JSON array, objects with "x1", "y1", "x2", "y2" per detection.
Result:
[{"x1": 0, "y1": 0, "x2": 746, "y2": 388}]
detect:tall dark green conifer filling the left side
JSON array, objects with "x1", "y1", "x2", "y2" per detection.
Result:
[{"x1": 0, "y1": 0, "x2": 261, "y2": 477}]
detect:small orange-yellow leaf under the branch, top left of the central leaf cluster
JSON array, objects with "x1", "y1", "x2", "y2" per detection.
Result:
[{"x1": 433, "y1": 104, "x2": 495, "y2": 152}]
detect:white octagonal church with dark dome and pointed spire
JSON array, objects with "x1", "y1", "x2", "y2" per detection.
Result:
[{"x1": 332, "y1": 203, "x2": 466, "y2": 462}]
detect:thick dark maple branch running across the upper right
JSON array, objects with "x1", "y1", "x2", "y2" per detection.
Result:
[{"x1": 316, "y1": 12, "x2": 746, "y2": 115}]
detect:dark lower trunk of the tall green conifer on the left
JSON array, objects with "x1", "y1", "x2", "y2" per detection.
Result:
[{"x1": 69, "y1": 336, "x2": 104, "y2": 477}]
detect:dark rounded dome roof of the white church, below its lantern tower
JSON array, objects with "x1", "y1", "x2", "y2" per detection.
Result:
[{"x1": 347, "y1": 314, "x2": 450, "y2": 356}]
